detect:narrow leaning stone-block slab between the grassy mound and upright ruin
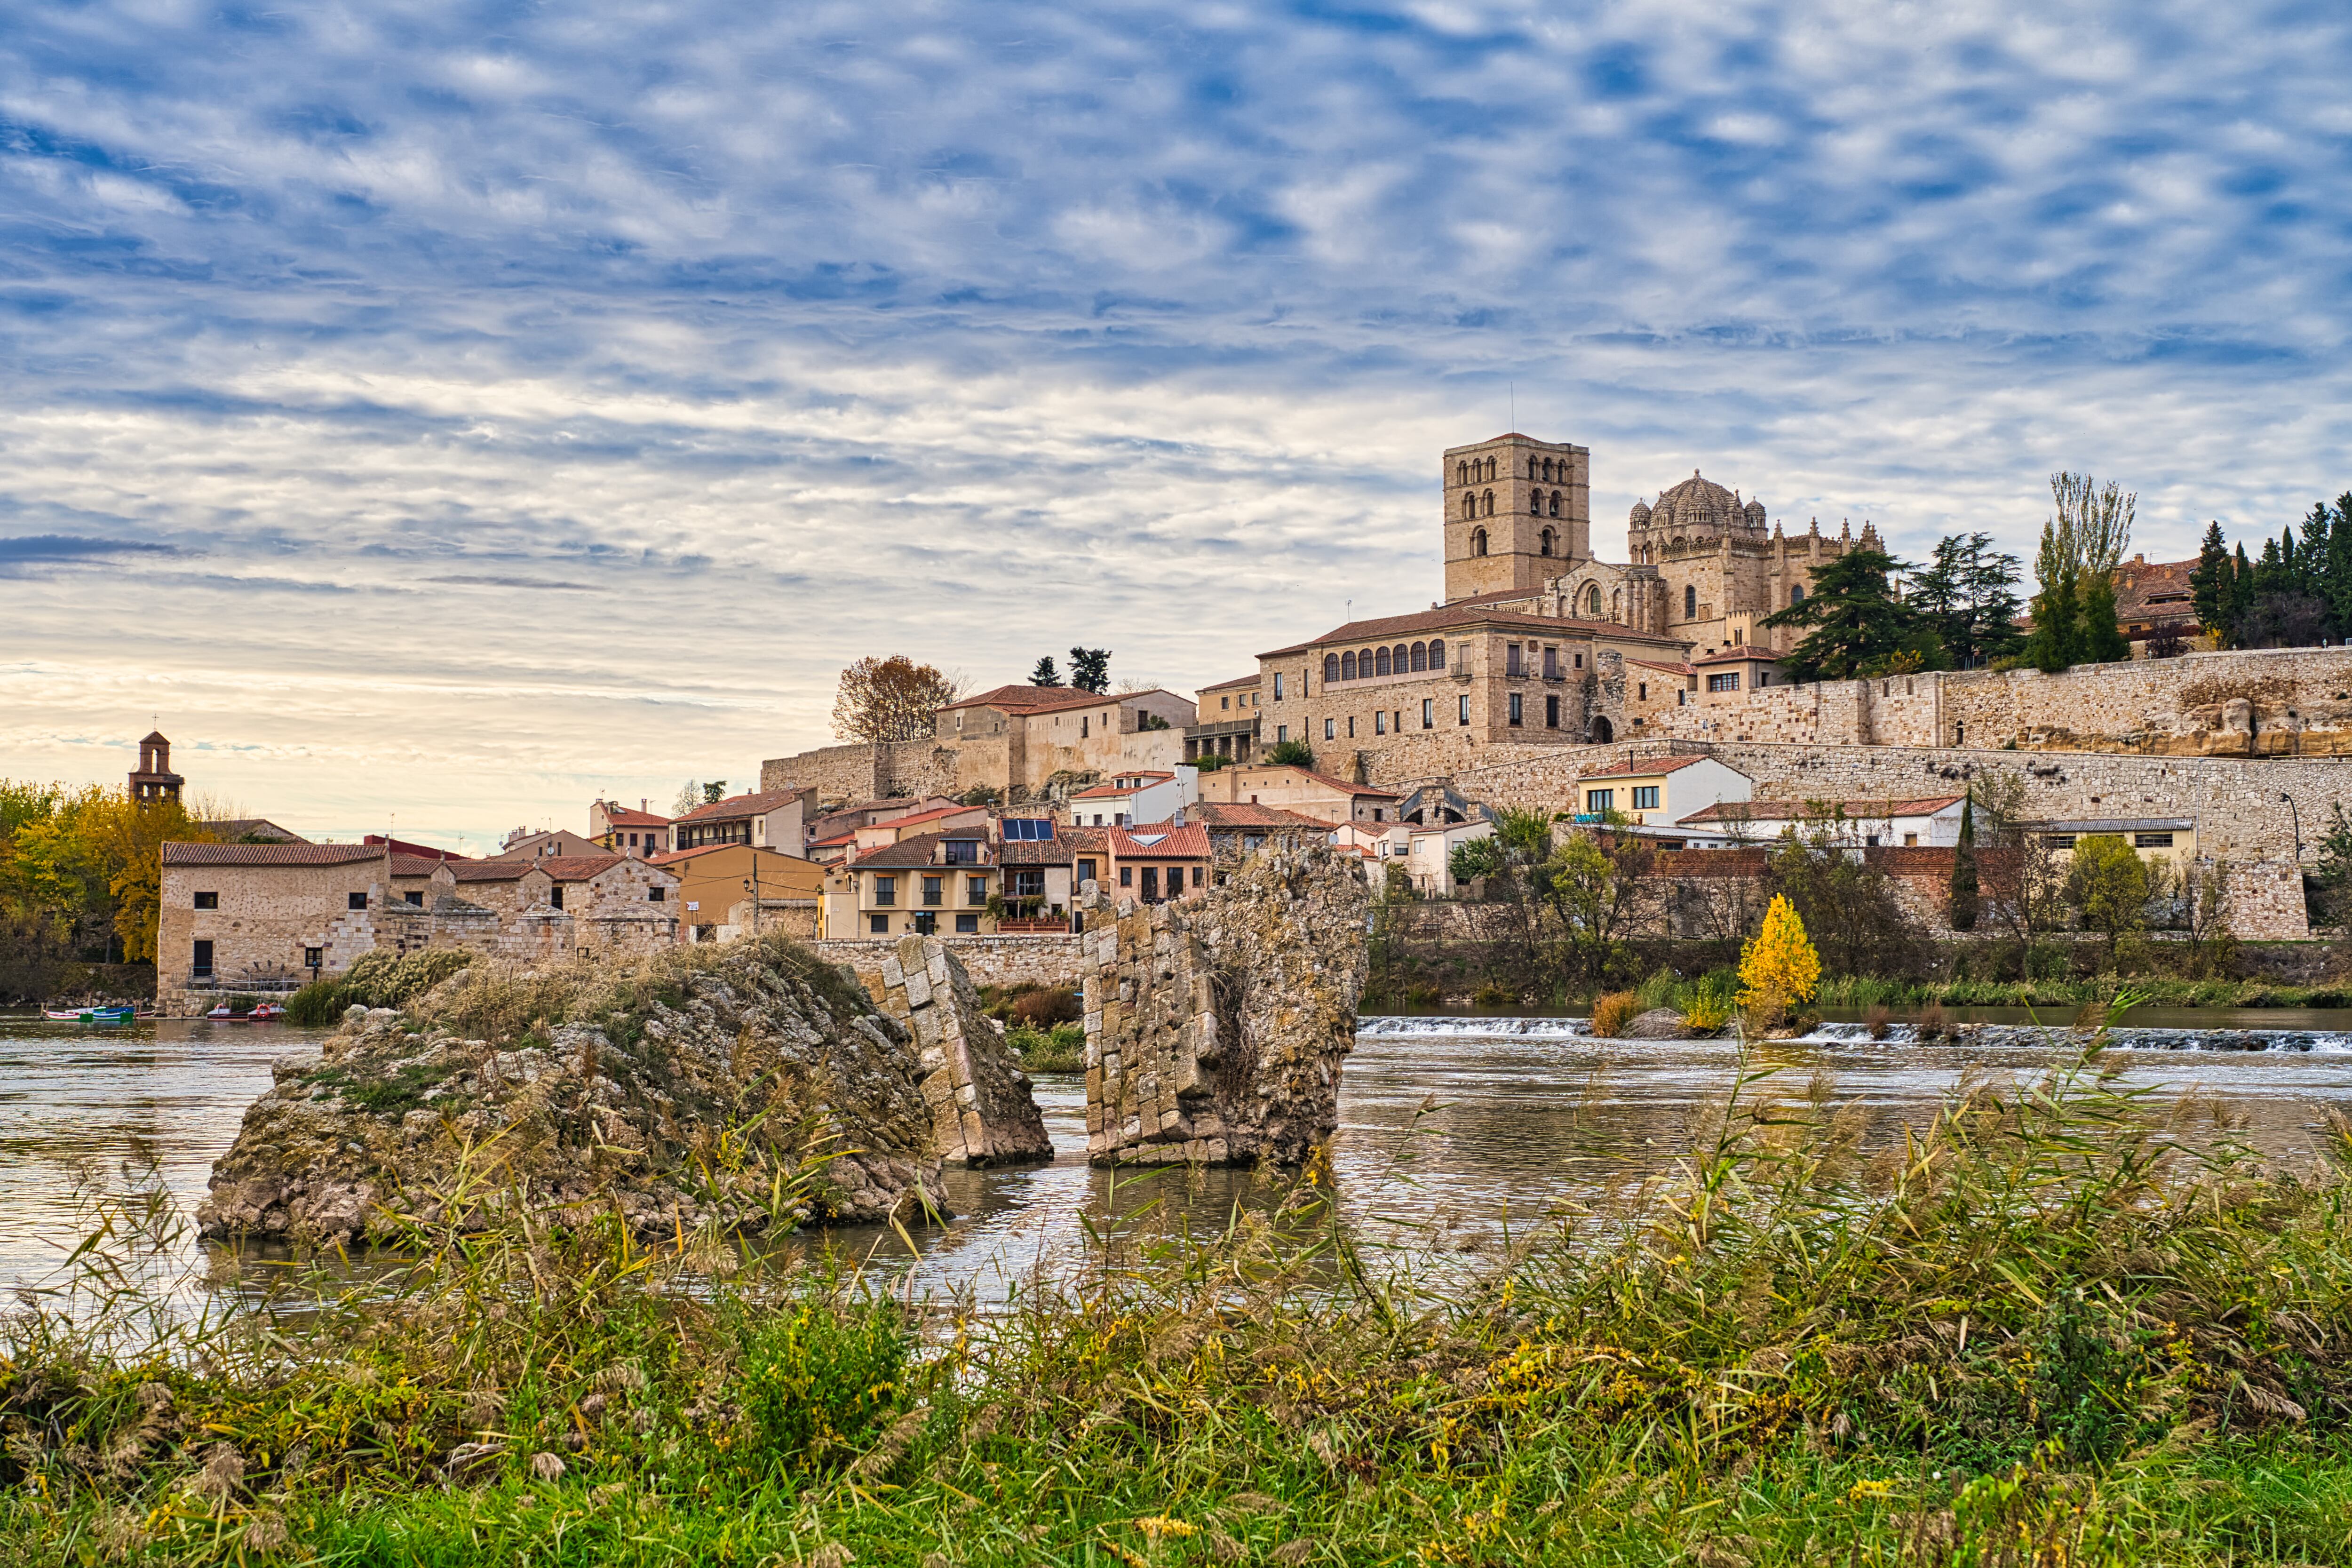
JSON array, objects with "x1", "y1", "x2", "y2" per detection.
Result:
[{"x1": 882, "y1": 936, "x2": 1054, "y2": 1169}]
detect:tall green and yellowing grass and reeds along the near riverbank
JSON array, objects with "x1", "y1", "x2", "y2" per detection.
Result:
[{"x1": 14, "y1": 1025, "x2": 2352, "y2": 1568}]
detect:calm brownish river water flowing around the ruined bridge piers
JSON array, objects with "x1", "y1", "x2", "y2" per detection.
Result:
[{"x1": 0, "y1": 1011, "x2": 2352, "y2": 1300}]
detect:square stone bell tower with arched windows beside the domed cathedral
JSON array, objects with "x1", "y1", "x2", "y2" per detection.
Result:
[{"x1": 1444, "y1": 432, "x2": 1592, "y2": 604}]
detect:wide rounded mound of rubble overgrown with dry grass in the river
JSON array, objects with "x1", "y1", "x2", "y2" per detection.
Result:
[{"x1": 198, "y1": 936, "x2": 1042, "y2": 1241}]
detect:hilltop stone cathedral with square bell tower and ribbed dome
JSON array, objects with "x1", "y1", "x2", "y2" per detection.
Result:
[{"x1": 1444, "y1": 435, "x2": 1879, "y2": 658}]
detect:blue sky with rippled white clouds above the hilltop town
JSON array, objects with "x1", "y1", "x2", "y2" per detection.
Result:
[{"x1": 0, "y1": 0, "x2": 2352, "y2": 851}]
